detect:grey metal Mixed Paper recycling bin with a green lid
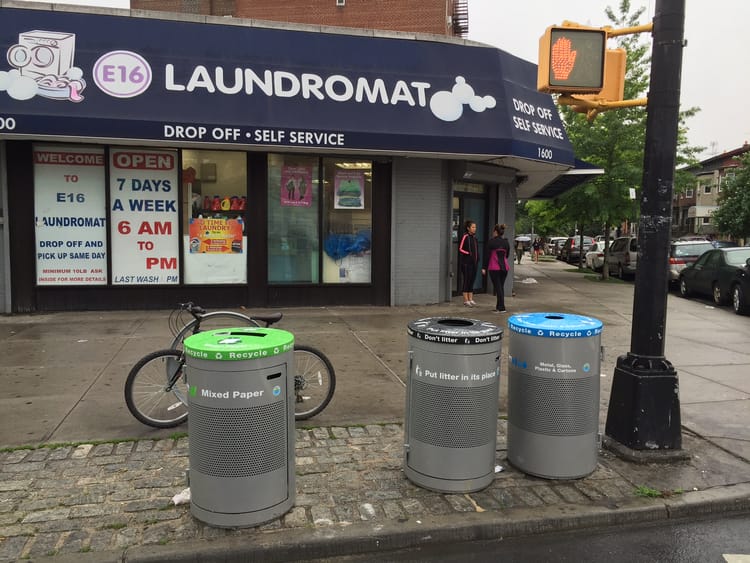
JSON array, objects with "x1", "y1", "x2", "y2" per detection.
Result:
[{"x1": 184, "y1": 328, "x2": 295, "y2": 528}]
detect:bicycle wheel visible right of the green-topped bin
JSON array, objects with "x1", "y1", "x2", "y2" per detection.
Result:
[{"x1": 294, "y1": 344, "x2": 336, "y2": 420}]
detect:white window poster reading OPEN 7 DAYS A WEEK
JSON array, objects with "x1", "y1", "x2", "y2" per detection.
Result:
[{"x1": 109, "y1": 147, "x2": 179, "y2": 285}]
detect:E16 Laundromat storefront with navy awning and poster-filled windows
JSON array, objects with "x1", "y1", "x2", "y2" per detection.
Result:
[{"x1": 0, "y1": 5, "x2": 574, "y2": 312}]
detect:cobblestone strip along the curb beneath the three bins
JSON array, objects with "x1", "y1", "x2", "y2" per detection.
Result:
[{"x1": 0, "y1": 421, "x2": 648, "y2": 561}]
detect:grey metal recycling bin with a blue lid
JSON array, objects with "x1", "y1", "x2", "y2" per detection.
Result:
[{"x1": 507, "y1": 313, "x2": 602, "y2": 479}]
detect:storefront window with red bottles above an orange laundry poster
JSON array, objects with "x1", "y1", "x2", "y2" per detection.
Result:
[{"x1": 181, "y1": 150, "x2": 249, "y2": 284}]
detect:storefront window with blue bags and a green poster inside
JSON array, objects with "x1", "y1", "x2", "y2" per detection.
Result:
[{"x1": 323, "y1": 159, "x2": 372, "y2": 283}]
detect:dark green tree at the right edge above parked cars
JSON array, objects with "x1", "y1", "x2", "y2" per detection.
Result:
[{"x1": 711, "y1": 153, "x2": 750, "y2": 239}]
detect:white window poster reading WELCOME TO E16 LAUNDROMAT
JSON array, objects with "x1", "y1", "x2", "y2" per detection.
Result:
[{"x1": 34, "y1": 145, "x2": 107, "y2": 285}]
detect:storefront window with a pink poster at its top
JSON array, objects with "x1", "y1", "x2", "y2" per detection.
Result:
[{"x1": 268, "y1": 154, "x2": 320, "y2": 283}]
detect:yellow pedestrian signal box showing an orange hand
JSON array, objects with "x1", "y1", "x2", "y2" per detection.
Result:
[{"x1": 537, "y1": 26, "x2": 607, "y2": 94}]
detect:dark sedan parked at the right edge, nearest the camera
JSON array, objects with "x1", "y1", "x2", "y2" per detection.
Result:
[{"x1": 680, "y1": 246, "x2": 750, "y2": 314}]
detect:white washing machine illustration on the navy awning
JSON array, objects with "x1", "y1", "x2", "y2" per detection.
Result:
[{"x1": 7, "y1": 29, "x2": 86, "y2": 102}]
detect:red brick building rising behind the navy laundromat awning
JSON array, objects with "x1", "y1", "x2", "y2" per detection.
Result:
[{"x1": 130, "y1": 0, "x2": 469, "y2": 37}]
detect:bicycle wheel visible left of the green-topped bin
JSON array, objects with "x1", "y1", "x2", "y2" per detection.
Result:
[{"x1": 125, "y1": 349, "x2": 188, "y2": 428}]
